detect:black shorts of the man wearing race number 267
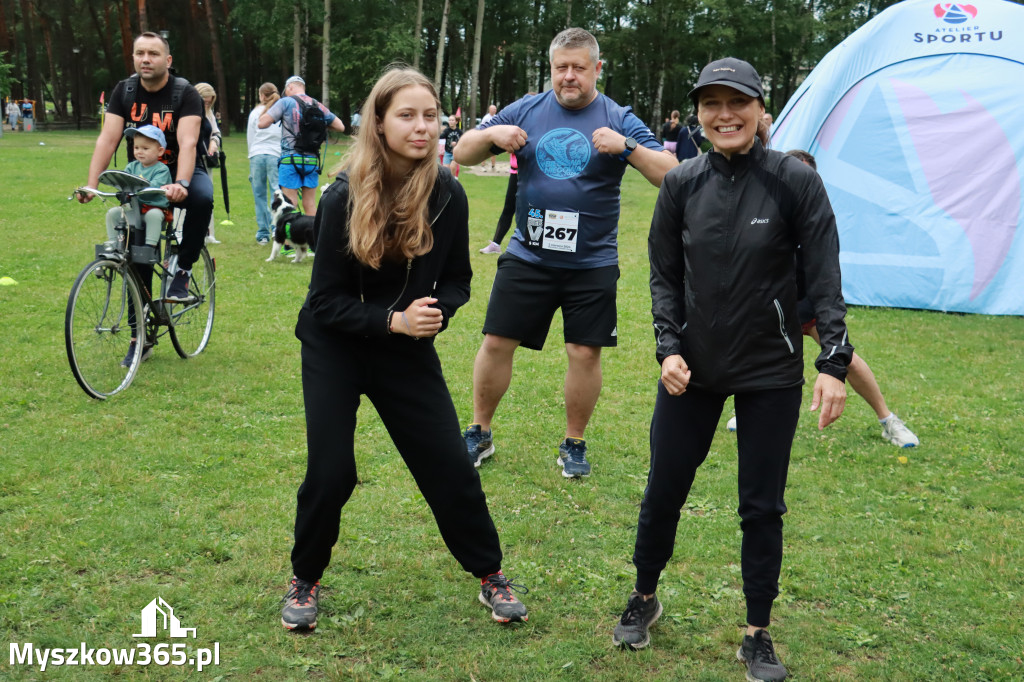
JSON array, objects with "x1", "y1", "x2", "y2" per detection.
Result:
[{"x1": 483, "y1": 254, "x2": 618, "y2": 350}]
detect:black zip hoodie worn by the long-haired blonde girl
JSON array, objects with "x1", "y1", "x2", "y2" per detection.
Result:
[{"x1": 296, "y1": 168, "x2": 473, "y2": 338}]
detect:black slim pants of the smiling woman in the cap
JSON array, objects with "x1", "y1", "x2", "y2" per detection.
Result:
[{"x1": 633, "y1": 382, "x2": 801, "y2": 627}]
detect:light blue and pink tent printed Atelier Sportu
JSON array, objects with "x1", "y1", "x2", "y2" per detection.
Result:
[{"x1": 771, "y1": 0, "x2": 1024, "y2": 314}]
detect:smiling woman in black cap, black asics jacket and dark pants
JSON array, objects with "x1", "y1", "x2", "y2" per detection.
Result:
[{"x1": 613, "y1": 58, "x2": 853, "y2": 682}]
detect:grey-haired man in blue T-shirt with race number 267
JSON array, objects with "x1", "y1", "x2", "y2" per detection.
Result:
[{"x1": 455, "y1": 28, "x2": 676, "y2": 478}]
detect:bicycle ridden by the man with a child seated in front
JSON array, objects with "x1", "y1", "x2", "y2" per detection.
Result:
[{"x1": 65, "y1": 170, "x2": 216, "y2": 399}]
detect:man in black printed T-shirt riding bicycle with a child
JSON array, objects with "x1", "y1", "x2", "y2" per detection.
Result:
[{"x1": 78, "y1": 32, "x2": 213, "y2": 302}]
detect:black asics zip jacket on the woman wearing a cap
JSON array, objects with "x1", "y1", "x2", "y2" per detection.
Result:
[{"x1": 648, "y1": 140, "x2": 853, "y2": 393}]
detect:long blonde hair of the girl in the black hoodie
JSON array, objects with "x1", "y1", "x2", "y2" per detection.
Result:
[{"x1": 344, "y1": 66, "x2": 440, "y2": 269}]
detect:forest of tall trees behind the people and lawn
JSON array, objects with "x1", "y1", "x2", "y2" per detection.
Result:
[{"x1": 0, "y1": 0, "x2": 978, "y2": 134}]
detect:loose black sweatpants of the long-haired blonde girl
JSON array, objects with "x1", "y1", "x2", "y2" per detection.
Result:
[{"x1": 292, "y1": 323, "x2": 502, "y2": 582}]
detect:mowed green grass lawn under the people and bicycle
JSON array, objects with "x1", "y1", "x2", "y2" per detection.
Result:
[{"x1": 0, "y1": 132, "x2": 1024, "y2": 681}]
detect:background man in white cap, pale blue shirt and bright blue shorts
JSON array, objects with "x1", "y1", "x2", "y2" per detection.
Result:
[{"x1": 256, "y1": 76, "x2": 345, "y2": 215}]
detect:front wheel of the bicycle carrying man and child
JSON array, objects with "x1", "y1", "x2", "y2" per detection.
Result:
[{"x1": 65, "y1": 258, "x2": 145, "y2": 399}]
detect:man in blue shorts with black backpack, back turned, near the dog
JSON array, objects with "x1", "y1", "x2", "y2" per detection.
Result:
[{"x1": 257, "y1": 76, "x2": 345, "y2": 215}]
